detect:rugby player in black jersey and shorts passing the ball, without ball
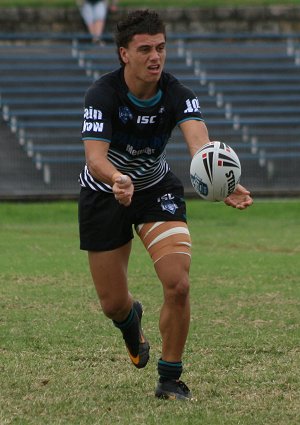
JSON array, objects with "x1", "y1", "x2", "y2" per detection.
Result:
[{"x1": 79, "y1": 10, "x2": 252, "y2": 399}]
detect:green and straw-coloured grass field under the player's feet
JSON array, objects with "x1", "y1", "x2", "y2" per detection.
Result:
[{"x1": 0, "y1": 200, "x2": 300, "y2": 425}]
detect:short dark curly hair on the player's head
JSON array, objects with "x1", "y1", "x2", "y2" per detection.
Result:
[{"x1": 115, "y1": 9, "x2": 166, "y2": 65}]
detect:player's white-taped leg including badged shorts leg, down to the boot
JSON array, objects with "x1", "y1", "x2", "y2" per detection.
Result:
[{"x1": 136, "y1": 169, "x2": 191, "y2": 399}]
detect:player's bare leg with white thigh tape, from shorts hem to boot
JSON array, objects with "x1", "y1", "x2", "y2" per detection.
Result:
[{"x1": 137, "y1": 221, "x2": 191, "y2": 399}]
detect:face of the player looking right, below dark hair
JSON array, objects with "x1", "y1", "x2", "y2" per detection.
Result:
[{"x1": 120, "y1": 34, "x2": 166, "y2": 83}]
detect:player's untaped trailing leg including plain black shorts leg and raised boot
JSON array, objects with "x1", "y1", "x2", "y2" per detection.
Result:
[{"x1": 79, "y1": 188, "x2": 149, "y2": 367}]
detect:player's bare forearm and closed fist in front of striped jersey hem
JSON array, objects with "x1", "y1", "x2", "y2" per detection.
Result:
[{"x1": 84, "y1": 140, "x2": 134, "y2": 206}]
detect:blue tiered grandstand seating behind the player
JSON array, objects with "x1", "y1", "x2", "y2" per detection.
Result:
[{"x1": 0, "y1": 33, "x2": 300, "y2": 198}]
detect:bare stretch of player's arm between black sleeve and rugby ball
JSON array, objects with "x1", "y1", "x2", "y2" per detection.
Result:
[{"x1": 179, "y1": 119, "x2": 210, "y2": 157}]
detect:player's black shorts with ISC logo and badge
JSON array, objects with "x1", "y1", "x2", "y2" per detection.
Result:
[{"x1": 79, "y1": 172, "x2": 186, "y2": 251}]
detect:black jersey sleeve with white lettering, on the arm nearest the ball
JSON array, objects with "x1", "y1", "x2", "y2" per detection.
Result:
[{"x1": 172, "y1": 84, "x2": 204, "y2": 125}]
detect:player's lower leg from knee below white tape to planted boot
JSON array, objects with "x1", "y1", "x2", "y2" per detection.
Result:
[{"x1": 155, "y1": 254, "x2": 192, "y2": 400}]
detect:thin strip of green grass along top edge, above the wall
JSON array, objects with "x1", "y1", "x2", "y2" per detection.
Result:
[{"x1": 0, "y1": 0, "x2": 300, "y2": 8}]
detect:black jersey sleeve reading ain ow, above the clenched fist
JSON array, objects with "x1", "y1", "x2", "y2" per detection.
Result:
[{"x1": 82, "y1": 85, "x2": 113, "y2": 142}]
